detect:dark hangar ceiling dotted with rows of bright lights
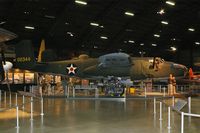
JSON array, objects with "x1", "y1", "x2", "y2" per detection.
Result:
[{"x1": 0, "y1": 0, "x2": 200, "y2": 56}]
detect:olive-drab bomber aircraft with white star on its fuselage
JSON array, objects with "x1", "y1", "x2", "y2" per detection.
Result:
[{"x1": 16, "y1": 40, "x2": 187, "y2": 80}]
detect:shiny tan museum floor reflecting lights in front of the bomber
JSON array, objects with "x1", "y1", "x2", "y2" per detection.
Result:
[{"x1": 0, "y1": 96, "x2": 200, "y2": 133}]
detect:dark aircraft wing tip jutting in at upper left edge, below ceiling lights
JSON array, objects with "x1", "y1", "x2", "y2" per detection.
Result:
[{"x1": 0, "y1": 28, "x2": 17, "y2": 42}]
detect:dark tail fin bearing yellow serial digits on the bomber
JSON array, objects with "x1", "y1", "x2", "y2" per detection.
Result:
[{"x1": 15, "y1": 40, "x2": 36, "y2": 69}]
